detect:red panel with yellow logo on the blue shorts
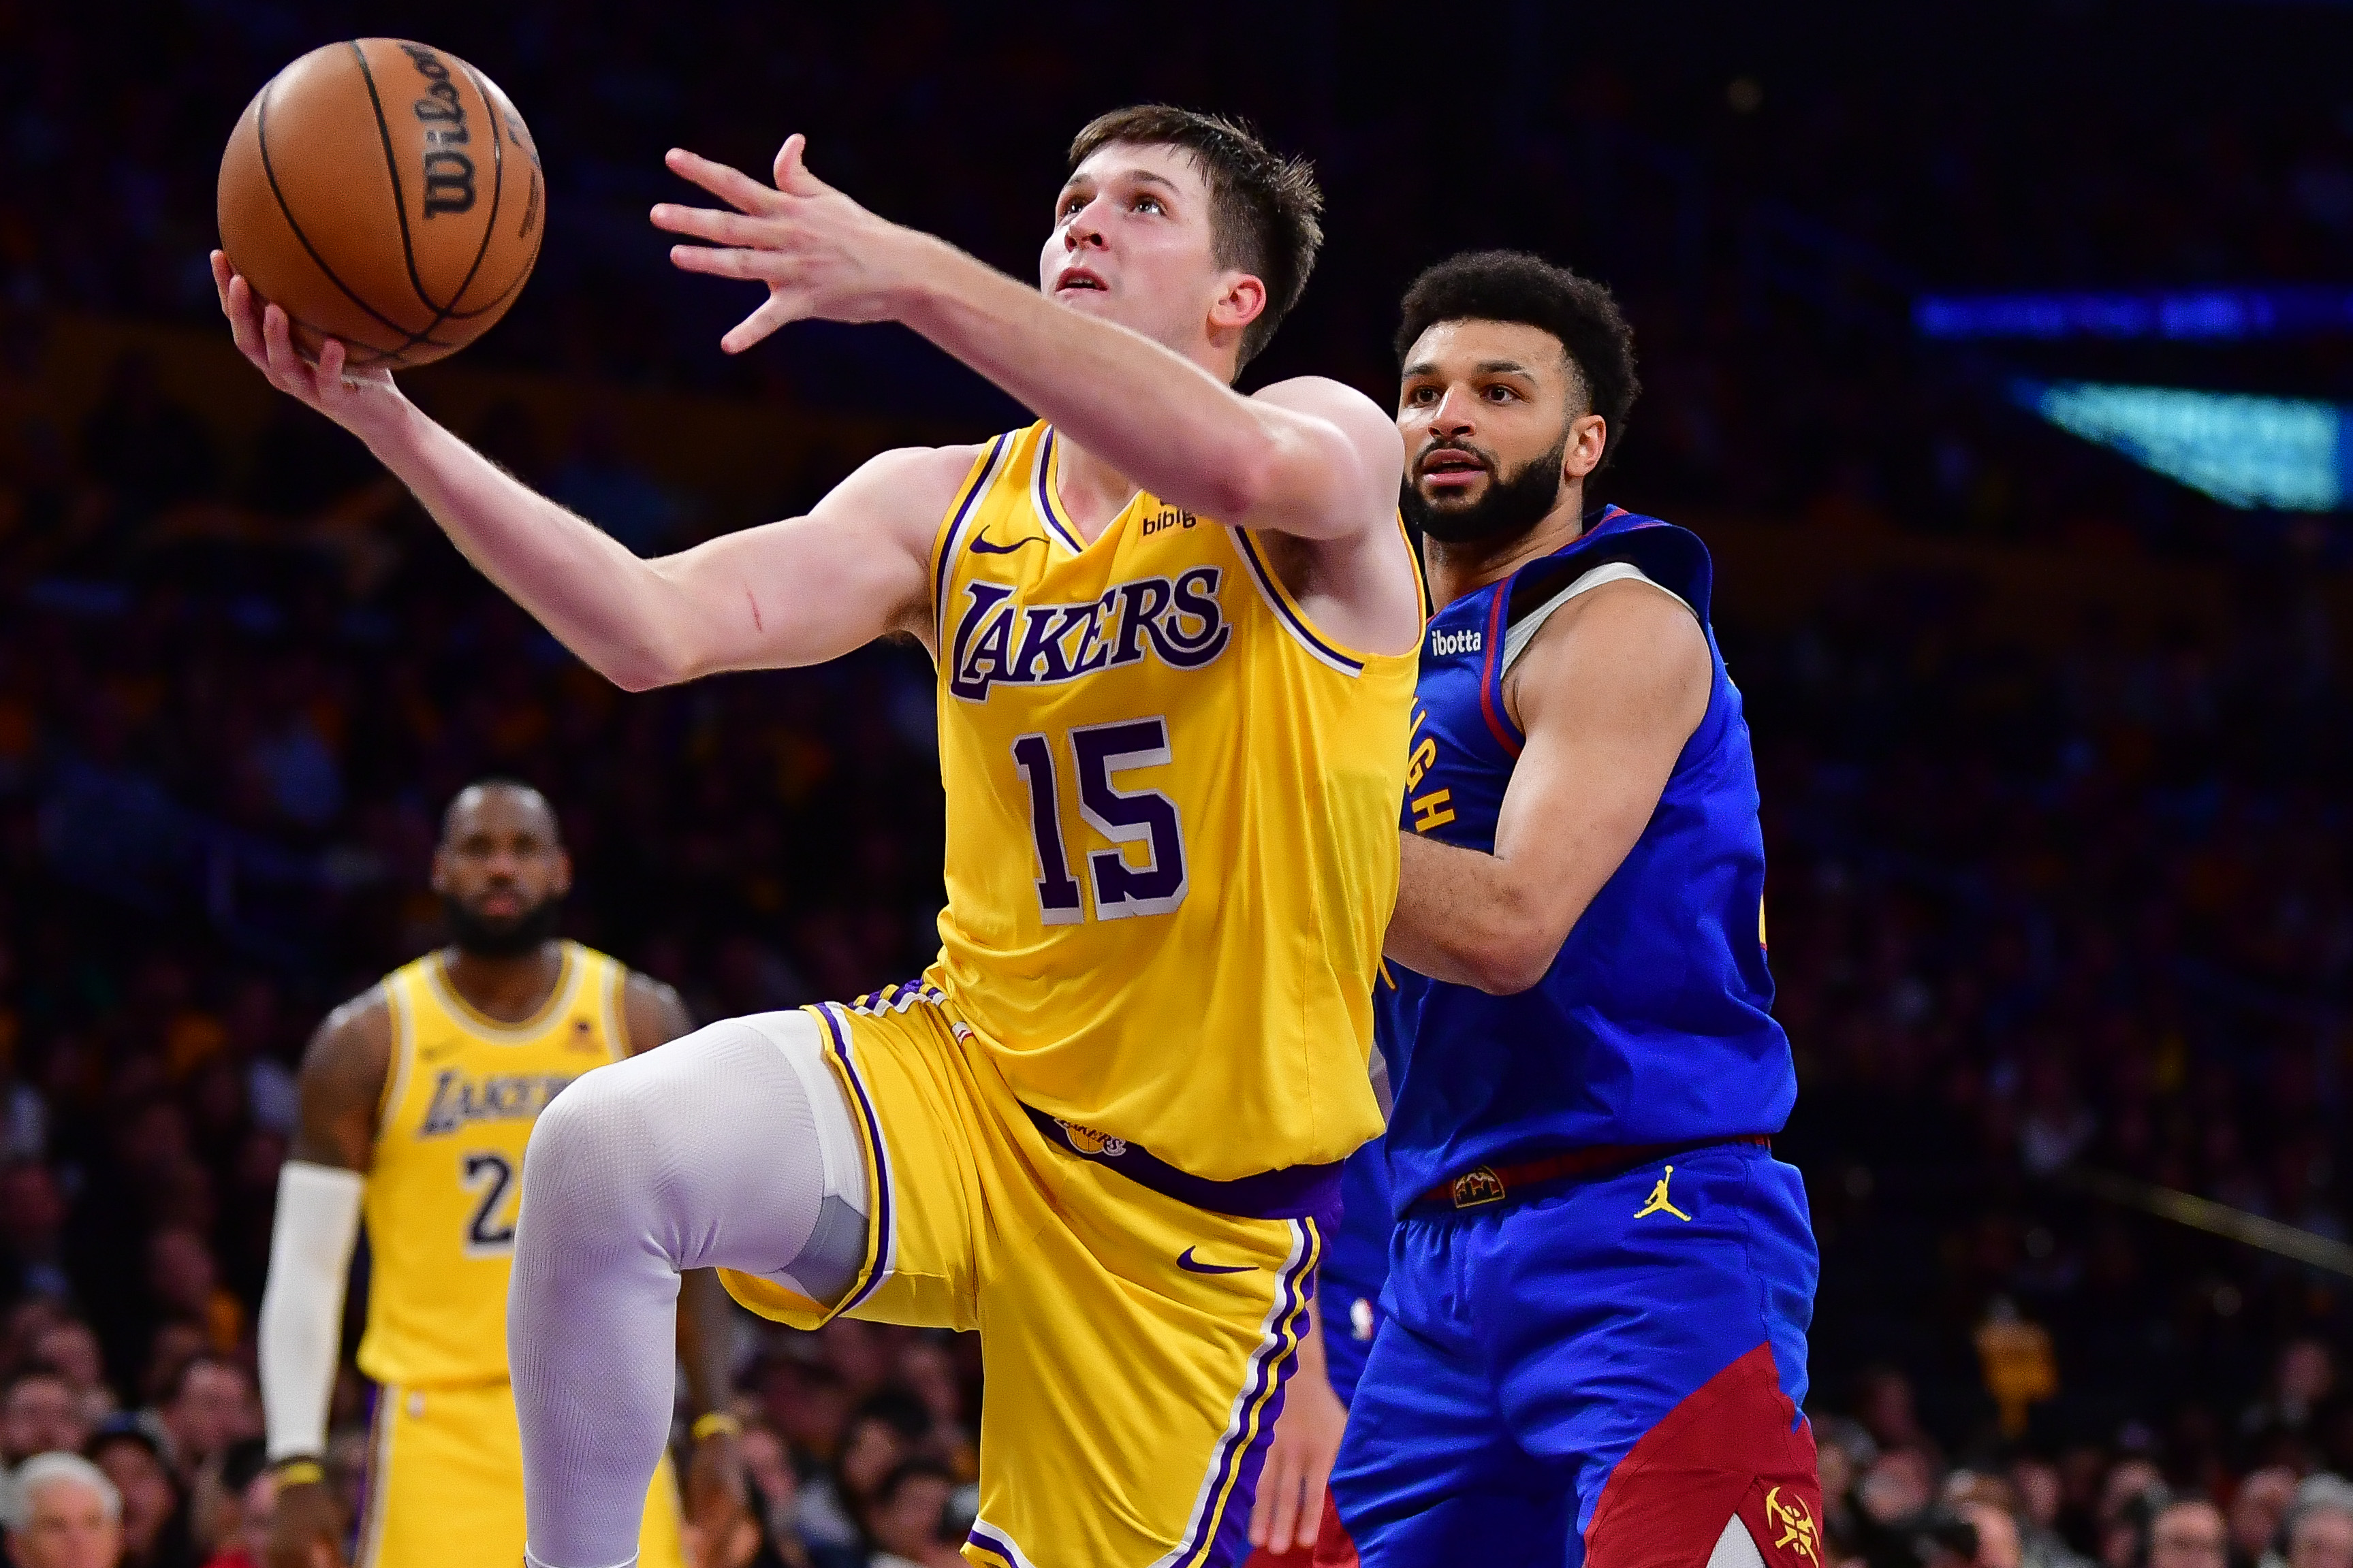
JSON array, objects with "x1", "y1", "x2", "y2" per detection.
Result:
[{"x1": 1586, "y1": 1345, "x2": 1829, "y2": 1568}]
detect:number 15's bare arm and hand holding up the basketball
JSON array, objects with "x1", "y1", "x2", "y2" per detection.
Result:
[{"x1": 212, "y1": 251, "x2": 977, "y2": 691}]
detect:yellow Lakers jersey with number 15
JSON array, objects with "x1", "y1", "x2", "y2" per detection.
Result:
[{"x1": 927, "y1": 423, "x2": 1417, "y2": 1180}]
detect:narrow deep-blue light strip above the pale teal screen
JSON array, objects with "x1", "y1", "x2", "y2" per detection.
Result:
[{"x1": 1913, "y1": 287, "x2": 2353, "y2": 343}]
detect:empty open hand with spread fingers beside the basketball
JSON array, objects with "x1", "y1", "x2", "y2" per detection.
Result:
[{"x1": 654, "y1": 134, "x2": 941, "y2": 355}]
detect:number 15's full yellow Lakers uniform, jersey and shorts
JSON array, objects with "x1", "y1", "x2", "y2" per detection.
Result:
[{"x1": 723, "y1": 426, "x2": 1414, "y2": 1568}]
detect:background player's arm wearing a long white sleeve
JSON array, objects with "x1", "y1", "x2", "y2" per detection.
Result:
[{"x1": 257, "y1": 990, "x2": 393, "y2": 1568}]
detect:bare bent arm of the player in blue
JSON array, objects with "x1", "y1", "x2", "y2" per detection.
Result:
[{"x1": 1386, "y1": 583, "x2": 1713, "y2": 995}]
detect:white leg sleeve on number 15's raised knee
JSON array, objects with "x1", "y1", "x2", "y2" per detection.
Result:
[{"x1": 506, "y1": 1013, "x2": 870, "y2": 1568}]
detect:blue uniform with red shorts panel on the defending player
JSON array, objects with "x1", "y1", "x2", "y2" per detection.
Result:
[{"x1": 1332, "y1": 508, "x2": 1821, "y2": 1568}]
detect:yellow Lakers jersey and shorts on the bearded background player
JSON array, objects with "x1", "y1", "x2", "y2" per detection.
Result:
[{"x1": 358, "y1": 943, "x2": 684, "y2": 1568}]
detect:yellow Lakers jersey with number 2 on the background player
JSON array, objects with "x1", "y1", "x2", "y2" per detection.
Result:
[{"x1": 360, "y1": 943, "x2": 628, "y2": 1387}]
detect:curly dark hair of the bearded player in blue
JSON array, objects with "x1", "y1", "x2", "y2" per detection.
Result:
[{"x1": 1397, "y1": 251, "x2": 1643, "y2": 473}]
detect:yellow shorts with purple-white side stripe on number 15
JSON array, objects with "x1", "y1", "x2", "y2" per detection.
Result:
[{"x1": 720, "y1": 985, "x2": 1336, "y2": 1568}]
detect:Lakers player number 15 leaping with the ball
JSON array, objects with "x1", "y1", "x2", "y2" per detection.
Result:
[{"x1": 214, "y1": 106, "x2": 1421, "y2": 1568}]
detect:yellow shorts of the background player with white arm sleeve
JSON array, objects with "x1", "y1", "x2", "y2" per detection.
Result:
[{"x1": 353, "y1": 1382, "x2": 687, "y2": 1568}]
